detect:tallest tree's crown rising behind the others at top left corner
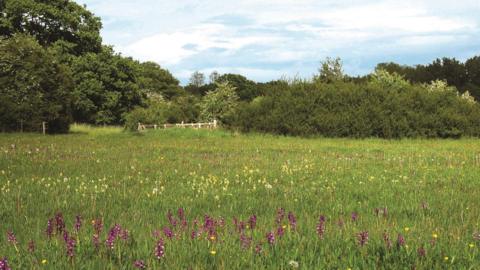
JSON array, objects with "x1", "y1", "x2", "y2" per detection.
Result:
[{"x1": 0, "y1": 0, "x2": 102, "y2": 55}]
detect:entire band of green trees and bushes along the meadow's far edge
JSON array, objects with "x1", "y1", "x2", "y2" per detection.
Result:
[{"x1": 0, "y1": 0, "x2": 480, "y2": 138}]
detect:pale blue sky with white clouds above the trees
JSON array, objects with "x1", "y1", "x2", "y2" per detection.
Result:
[{"x1": 77, "y1": 0, "x2": 480, "y2": 83}]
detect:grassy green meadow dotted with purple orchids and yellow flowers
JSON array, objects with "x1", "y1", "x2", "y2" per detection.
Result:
[{"x1": 0, "y1": 126, "x2": 480, "y2": 269}]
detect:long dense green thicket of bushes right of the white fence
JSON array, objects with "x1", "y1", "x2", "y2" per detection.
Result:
[{"x1": 231, "y1": 70, "x2": 480, "y2": 138}]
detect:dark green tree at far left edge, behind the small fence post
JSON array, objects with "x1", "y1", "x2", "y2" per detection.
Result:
[{"x1": 0, "y1": 35, "x2": 73, "y2": 133}]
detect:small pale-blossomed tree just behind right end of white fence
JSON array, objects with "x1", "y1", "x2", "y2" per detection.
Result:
[{"x1": 200, "y1": 82, "x2": 238, "y2": 123}]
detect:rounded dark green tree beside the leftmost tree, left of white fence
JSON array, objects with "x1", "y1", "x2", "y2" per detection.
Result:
[{"x1": 72, "y1": 46, "x2": 145, "y2": 124}]
